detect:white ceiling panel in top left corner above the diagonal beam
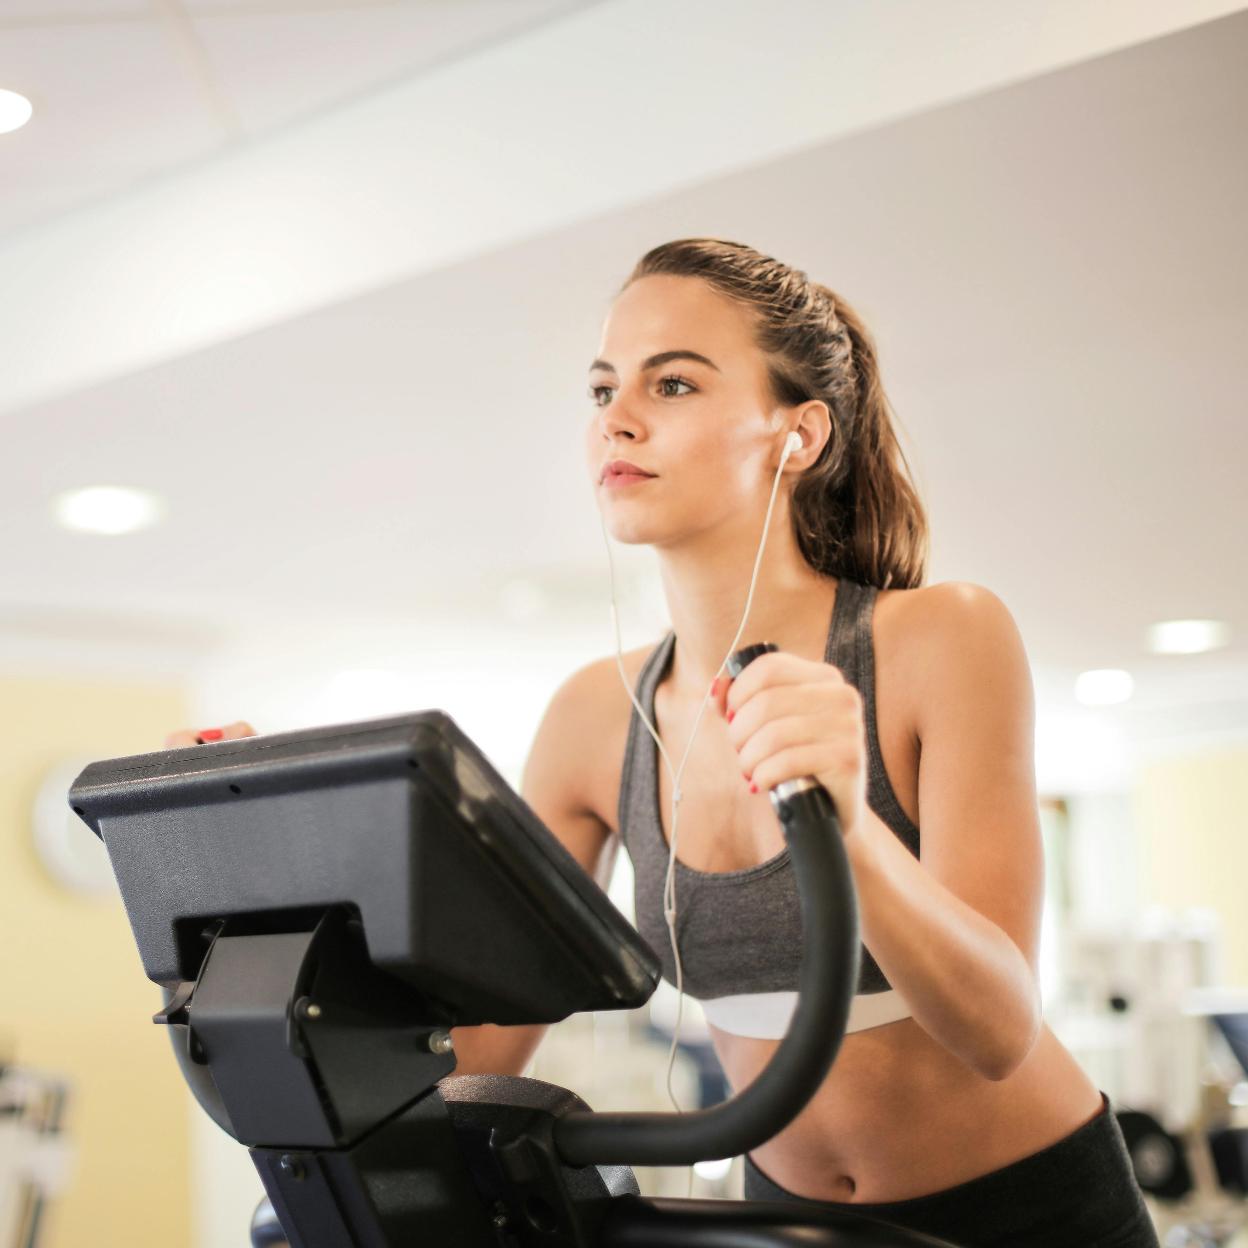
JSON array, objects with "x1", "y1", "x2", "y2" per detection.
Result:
[{"x1": 0, "y1": 0, "x2": 584, "y2": 233}]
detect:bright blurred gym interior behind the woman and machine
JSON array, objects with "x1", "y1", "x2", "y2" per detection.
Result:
[{"x1": 0, "y1": 0, "x2": 1248, "y2": 1248}]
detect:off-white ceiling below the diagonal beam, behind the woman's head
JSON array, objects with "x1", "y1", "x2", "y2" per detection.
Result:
[{"x1": 0, "y1": 0, "x2": 1248, "y2": 778}]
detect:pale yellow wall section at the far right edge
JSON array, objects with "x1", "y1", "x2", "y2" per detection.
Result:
[{"x1": 1132, "y1": 746, "x2": 1248, "y2": 986}]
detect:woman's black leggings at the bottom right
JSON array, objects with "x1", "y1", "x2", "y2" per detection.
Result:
[{"x1": 745, "y1": 1092, "x2": 1158, "y2": 1248}]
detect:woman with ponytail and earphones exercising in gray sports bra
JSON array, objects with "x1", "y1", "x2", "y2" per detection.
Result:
[{"x1": 168, "y1": 240, "x2": 1157, "y2": 1248}]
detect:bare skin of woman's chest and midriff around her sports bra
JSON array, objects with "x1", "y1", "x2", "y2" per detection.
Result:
[{"x1": 594, "y1": 590, "x2": 1102, "y2": 1203}]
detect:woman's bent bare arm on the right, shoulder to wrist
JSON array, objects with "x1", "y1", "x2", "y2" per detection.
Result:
[{"x1": 846, "y1": 582, "x2": 1045, "y2": 1080}]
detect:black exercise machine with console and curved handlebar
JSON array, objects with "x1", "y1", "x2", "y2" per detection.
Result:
[{"x1": 69, "y1": 673, "x2": 951, "y2": 1248}]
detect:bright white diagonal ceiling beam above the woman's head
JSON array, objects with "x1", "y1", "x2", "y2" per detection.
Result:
[{"x1": 0, "y1": 0, "x2": 1243, "y2": 413}]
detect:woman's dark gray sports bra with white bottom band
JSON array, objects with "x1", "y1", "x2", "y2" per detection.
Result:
[{"x1": 618, "y1": 578, "x2": 919, "y2": 1038}]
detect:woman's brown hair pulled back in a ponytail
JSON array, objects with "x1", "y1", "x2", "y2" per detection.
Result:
[{"x1": 624, "y1": 238, "x2": 929, "y2": 589}]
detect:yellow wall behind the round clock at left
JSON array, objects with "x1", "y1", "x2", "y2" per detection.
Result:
[{"x1": 0, "y1": 674, "x2": 191, "y2": 1248}]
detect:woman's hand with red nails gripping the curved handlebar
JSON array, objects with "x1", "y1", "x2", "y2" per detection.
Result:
[{"x1": 710, "y1": 650, "x2": 866, "y2": 837}]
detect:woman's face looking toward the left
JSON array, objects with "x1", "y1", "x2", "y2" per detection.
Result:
[{"x1": 585, "y1": 275, "x2": 784, "y2": 547}]
